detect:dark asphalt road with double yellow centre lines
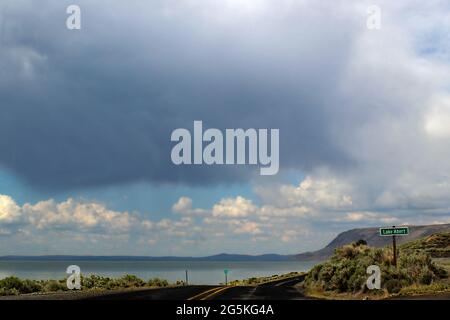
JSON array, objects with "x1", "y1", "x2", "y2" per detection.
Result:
[{"x1": 88, "y1": 276, "x2": 306, "y2": 300}]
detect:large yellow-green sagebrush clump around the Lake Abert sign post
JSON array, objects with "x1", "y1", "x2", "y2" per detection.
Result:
[{"x1": 304, "y1": 242, "x2": 447, "y2": 293}]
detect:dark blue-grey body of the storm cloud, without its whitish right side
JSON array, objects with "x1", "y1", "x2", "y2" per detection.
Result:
[{"x1": 0, "y1": 1, "x2": 360, "y2": 188}]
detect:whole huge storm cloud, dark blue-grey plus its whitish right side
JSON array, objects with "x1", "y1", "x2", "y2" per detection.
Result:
[{"x1": 0, "y1": 0, "x2": 447, "y2": 195}]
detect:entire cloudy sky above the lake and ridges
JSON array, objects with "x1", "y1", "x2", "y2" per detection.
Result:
[{"x1": 0, "y1": 0, "x2": 450, "y2": 256}]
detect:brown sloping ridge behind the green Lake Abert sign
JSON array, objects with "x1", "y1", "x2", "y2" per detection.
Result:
[{"x1": 294, "y1": 224, "x2": 450, "y2": 261}]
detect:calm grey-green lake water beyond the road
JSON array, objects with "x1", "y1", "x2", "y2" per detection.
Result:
[{"x1": 0, "y1": 261, "x2": 315, "y2": 284}]
